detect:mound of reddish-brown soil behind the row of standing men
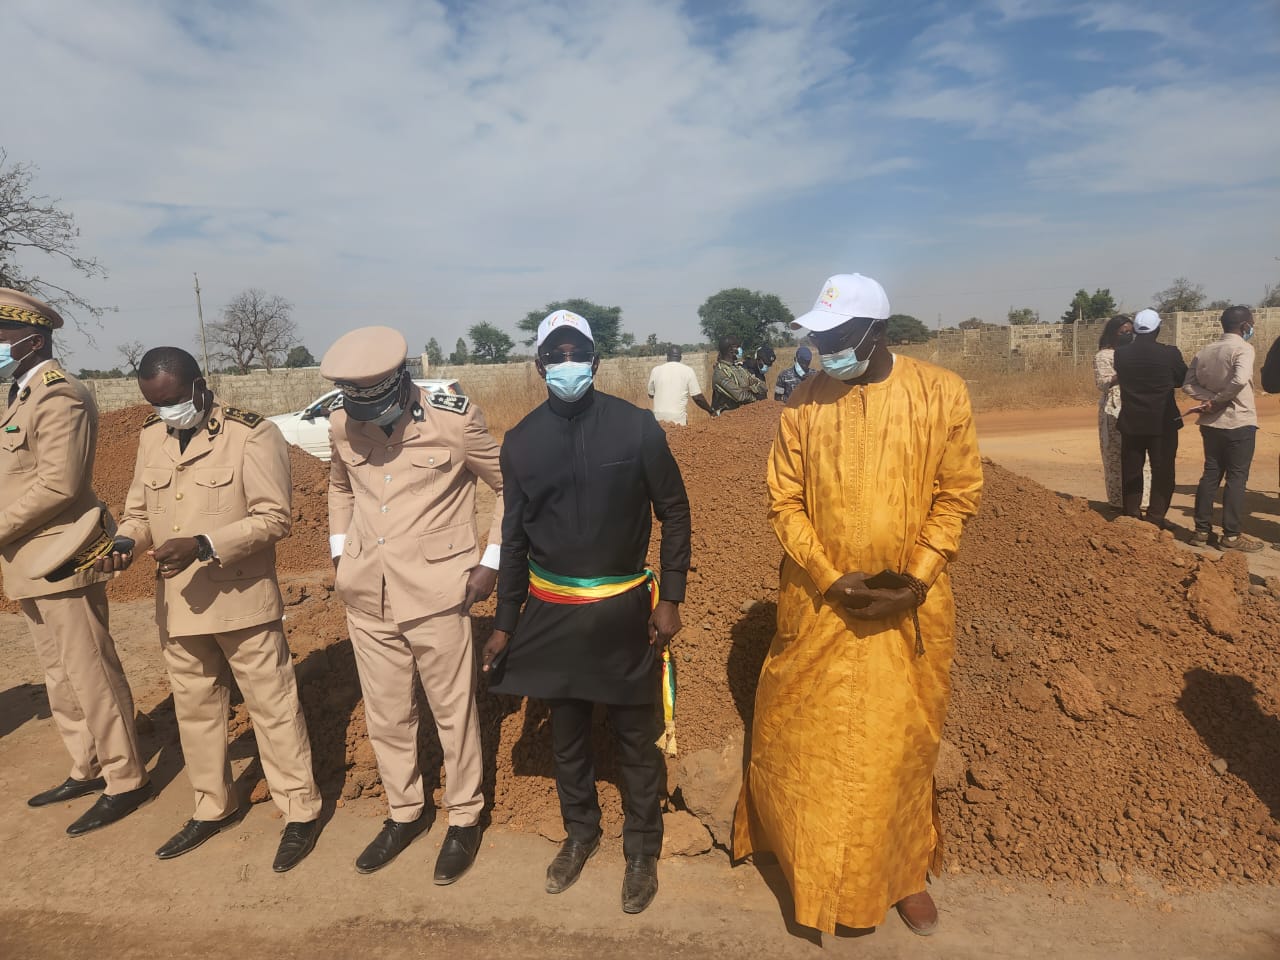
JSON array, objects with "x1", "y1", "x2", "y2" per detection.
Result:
[{"x1": 12, "y1": 402, "x2": 1280, "y2": 886}]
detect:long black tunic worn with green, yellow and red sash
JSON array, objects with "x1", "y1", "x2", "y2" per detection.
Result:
[{"x1": 490, "y1": 389, "x2": 690, "y2": 704}]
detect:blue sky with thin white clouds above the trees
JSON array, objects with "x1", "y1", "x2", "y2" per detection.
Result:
[{"x1": 0, "y1": 0, "x2": 1280, "y2": 367}]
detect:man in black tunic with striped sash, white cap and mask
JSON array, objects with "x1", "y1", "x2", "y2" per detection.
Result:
[{"x1": 483, "y1": 311, "x2": 690, "y2": 913}]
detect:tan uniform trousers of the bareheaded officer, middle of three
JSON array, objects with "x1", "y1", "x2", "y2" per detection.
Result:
[{"x1": 160, "y1": 621, "x2": 320, "y2": 823}]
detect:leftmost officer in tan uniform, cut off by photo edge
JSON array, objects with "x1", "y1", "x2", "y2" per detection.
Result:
[{"x1": 0, "y1": 288, "x2": 151, "y2": 836}]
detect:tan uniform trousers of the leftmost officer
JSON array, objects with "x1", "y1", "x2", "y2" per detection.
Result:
[{"x1": 20, "y1": 584, "x2": 147, "y2": 795}]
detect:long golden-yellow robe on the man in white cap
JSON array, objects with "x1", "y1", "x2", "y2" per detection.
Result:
[{"x1": 733, "y1": 356, "x2": 982, "y2": 933}]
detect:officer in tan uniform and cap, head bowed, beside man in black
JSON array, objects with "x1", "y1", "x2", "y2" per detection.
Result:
[{"x1": 320, "y1": 326, "x2": 502, "y2": 884}]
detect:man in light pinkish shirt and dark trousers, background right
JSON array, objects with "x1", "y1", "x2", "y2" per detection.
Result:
[{"x1": 1183, "y1": 307, "x2": 1262, "y2": 553}]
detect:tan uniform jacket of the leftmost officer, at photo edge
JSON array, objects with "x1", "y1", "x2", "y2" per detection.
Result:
[{"x1": 0, "y1": 364, "x2": 108, "y2": 600}]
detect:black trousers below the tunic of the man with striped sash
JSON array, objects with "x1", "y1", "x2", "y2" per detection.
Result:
[{"x1": 550, "y1": 700, "x2": 664, "y2": 856}]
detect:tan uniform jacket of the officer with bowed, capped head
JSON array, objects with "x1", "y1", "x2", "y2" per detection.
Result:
[{"x1": 329, "y1": 390, "x2": 502, "y2": 623}]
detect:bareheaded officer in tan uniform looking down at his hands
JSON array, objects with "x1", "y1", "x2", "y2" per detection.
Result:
[{"x1": 102, "y1": 347, "x2": 320, "y2": 873}]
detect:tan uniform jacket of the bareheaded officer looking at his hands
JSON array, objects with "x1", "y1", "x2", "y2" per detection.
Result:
[{"x1": 119, "y1": 402, "x2": 293, "y2": 636}]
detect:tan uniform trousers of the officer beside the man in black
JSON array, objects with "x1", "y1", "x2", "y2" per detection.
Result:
[{"x1": 347, "y1": 590, "x2": 484, "y2": 827}]
